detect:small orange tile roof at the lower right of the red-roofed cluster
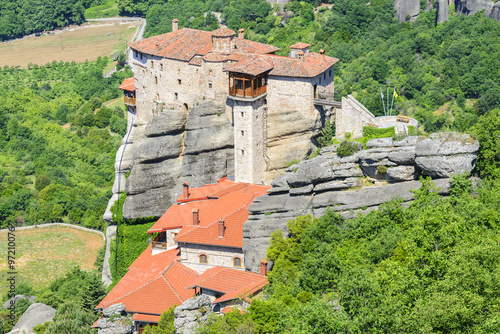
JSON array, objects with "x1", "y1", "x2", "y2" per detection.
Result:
[{"x1": 194, "y1": 267, "x2": 267, "y2": 303}]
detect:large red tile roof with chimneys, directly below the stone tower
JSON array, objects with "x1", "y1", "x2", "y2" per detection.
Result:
[{"x1": 148, "y1": 178, "x2": 270, "y2": 248}]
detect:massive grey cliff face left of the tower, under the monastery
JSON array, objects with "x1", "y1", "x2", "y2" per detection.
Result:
[{"x1": 111, "y1": 101, "x2": 234, "y2": 219}]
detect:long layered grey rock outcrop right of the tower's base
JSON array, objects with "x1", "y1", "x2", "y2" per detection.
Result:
[{"x1": 243, "y1": 133, "x2": 479, "y2": 272}]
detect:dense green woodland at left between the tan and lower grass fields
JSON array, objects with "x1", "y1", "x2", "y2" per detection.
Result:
[{"x1": 0, "y1": 59, "x2": 132, "y2": 228}]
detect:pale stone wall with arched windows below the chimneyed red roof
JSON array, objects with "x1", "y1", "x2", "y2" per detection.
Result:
[{"x1": 181, "y1": 244, "x2": 245, "y2": 273}]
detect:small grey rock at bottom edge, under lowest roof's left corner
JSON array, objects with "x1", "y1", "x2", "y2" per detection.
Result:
[{"x1": 97, "y1": 303, "x2": 134, "y2": 334}]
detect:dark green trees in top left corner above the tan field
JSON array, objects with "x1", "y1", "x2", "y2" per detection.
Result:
[{"x1": 0, "y1": 0, "x2": 87, "y2": 41}]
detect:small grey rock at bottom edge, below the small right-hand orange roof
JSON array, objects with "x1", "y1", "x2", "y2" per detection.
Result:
[{"x1": 174, "y1": 296, "x2": 213, "y2": 334}]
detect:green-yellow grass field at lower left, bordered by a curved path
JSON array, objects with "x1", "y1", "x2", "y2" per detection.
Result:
[{"x1": 0, "y1": 226, "x2": 103, "y2": 296}]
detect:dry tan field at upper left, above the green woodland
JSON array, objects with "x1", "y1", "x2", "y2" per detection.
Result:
[{"x1": 0, "y1": 23, "x2": 138, "y2": 68}]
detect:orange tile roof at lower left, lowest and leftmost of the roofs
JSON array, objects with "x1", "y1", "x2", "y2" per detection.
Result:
[{"x1": 96, "y1": 246, "x2": 198, "y2": 315}]
